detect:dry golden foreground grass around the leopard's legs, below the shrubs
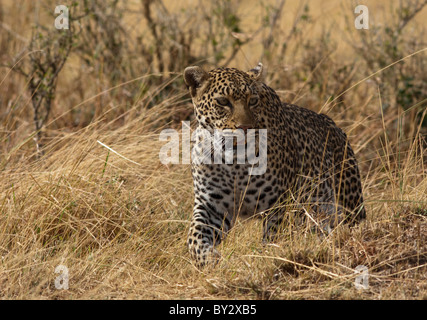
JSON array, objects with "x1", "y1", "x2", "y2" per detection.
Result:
[{"x1": 0, "y1": 90, "x2": 427, "y2": 299}]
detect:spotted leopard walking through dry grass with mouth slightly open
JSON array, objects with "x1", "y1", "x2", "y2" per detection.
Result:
[{"x1": 184, "y1": 63, "x2": 366, "y2": 267}]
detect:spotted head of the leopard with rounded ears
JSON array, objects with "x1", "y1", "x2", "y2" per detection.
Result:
[{"x1": 184, "y1": 63, "x2": 263, "y2": 130}]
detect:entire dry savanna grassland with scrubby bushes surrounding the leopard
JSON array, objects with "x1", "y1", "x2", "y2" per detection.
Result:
[{"x1": 0, "y1": 0, "x2": 427, "y2": 299}]
